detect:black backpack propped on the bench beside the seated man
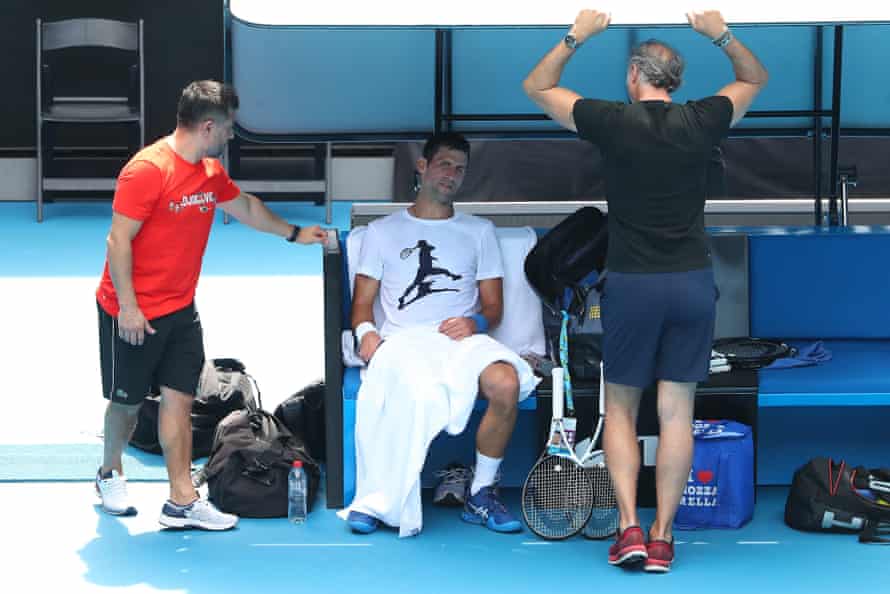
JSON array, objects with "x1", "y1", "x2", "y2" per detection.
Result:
[{"x1": 525, "y1": 206, "x2": 608, "y2": 380}]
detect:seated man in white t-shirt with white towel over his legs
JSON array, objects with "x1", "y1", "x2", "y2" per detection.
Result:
[{"x1": 341, "y1": 133, "x2": 536, "y2": 536}]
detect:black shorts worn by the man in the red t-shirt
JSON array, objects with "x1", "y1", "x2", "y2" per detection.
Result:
[{"x1": 96, "y1": 303, "x2": 204, "y2": 405}]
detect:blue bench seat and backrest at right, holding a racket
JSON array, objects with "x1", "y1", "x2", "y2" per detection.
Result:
[{"x1": 749, "y1": 227, "x2": 890, "y2": 484}]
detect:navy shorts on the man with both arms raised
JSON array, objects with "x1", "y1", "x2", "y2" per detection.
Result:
[{"x1": 601, "y1": 268, "x2": 718, "y2": 388}]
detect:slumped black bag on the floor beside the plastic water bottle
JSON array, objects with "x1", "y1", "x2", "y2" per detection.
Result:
[{"x1": 193, "y1": 409, "x2": 321, "y2": 518}]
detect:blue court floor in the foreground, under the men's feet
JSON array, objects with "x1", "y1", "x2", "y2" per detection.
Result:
[{"x1": 0, "y1": 482, "x2": 888, "y2": 594}]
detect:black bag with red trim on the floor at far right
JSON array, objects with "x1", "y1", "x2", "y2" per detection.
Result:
[{"x1": 785, "y1": 458, "x2": 890, "y2": 542}]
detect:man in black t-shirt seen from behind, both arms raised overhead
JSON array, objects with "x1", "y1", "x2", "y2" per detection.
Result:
[{"x1": 523, "y1": 10, "x2": 767, "y2": 572}]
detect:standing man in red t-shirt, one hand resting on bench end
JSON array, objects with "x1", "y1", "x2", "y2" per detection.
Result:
[{"x1": 96, "y1": 80, "x2": 326, "y2": 530}]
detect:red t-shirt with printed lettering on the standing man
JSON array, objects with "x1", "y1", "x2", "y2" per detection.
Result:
[{"x1": 96, "y1": 138, "x2": 241, "y2": 320}]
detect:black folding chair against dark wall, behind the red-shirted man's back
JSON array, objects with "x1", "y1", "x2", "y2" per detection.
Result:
[{"x1": 37, "y1": 18, "x2": 145, "y2": 222}]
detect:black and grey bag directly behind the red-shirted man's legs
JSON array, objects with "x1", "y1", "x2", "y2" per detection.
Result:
[{"x1": 130, "y1": 359, "x2": 259, "y2": 460}]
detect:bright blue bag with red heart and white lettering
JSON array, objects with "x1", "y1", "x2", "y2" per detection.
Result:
[{"x1": 674, "y1": 421, "x2": 754, "y2": 530}]
